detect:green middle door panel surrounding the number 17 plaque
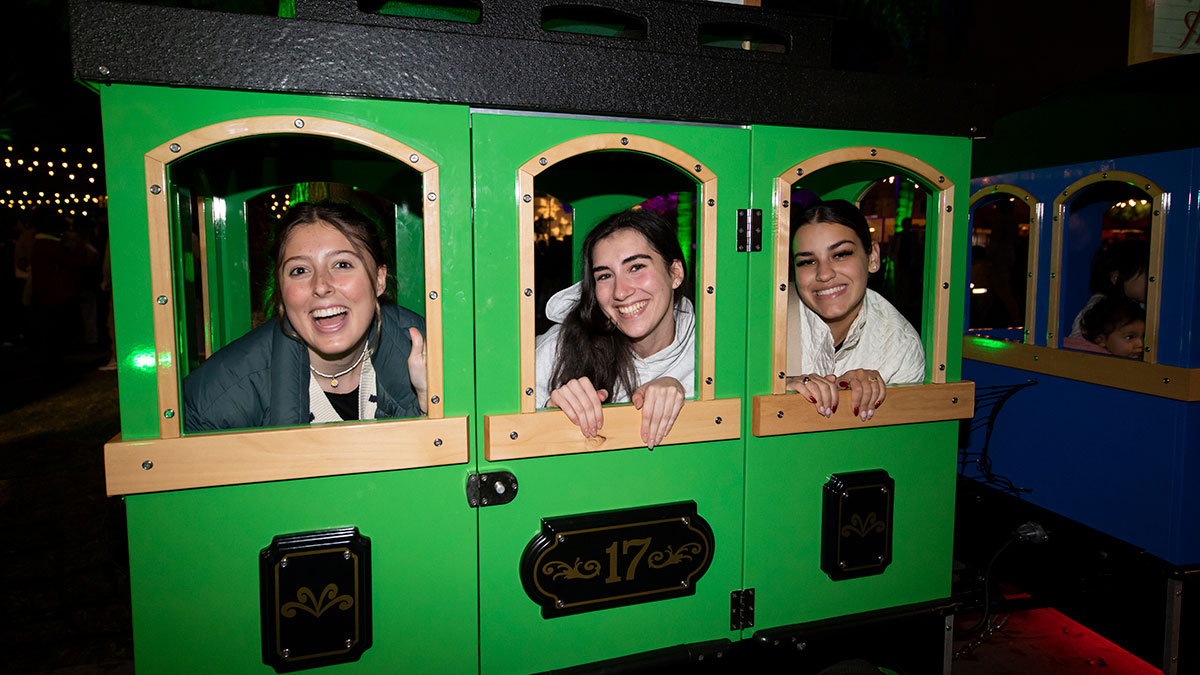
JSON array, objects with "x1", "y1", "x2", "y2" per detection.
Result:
[{"x1": 472, "y1": 114, "x2": 749, "y2": 674}]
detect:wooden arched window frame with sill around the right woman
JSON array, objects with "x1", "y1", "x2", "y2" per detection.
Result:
[{"x1": 751, "y1": 147, "x2": 974, "y2": 436}]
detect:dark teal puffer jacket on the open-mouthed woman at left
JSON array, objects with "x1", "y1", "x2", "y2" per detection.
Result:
[{"x1": 184, "y1": 305, "x2": 425, "y2": 431}]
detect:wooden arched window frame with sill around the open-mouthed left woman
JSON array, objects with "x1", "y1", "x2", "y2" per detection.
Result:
[{"x1": 104, "y1": 115, "x2": 468, "y2": 495}]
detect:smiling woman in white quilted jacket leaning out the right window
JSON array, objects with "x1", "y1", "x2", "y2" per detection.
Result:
[{"x1": 787, "y1": 199, "x2": 925, "y2": 422}]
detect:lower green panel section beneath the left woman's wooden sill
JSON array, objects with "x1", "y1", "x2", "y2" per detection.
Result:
[{"x1": 126, "y1": 466, "x2": 478, "y2": 674}]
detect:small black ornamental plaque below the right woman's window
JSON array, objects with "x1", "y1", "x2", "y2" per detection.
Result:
[{"x1": 821, "y1": 470, "x2": 895, "y2": 581}]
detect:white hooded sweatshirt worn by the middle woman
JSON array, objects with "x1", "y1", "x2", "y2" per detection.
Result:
[{"x1": 534, "y1": 283, "x2": 696, "y2": 408}]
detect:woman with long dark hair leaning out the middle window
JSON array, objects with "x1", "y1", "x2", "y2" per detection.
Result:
[{"x1": 534, "y1": 209, "x2": 696, "y2": 449}]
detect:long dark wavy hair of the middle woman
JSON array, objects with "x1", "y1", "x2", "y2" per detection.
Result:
[{"x1": 550, "y1": 209, "x2": 686, "y2": 396}]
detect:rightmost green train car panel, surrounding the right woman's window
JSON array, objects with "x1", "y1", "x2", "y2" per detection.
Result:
[{"x1": 745, "y1": 126, "x2": 971, "y2": 637}]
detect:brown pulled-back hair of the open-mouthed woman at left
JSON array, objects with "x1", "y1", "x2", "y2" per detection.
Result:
[{"x1": 269, "y1": 201, "x2": 394, "y2": 319}]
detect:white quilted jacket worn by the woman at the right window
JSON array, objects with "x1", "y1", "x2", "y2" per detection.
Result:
[{"x1": 787, "y1": 286, "x2": 925, "y2": 384}]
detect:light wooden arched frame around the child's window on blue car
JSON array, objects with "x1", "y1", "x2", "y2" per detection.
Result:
[{"x1": 1046, "y1": 171, "x2": 1166, "y2": 363}]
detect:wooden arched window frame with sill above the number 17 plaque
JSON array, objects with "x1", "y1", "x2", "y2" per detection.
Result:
[{"x1": 484, "y1": 133, "x2": 740, "y2": 461}]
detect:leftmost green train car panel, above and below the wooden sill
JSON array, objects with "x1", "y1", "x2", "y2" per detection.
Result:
[{"x1": 101, "y1": 85, "x2": 478, "y2": 673}]
